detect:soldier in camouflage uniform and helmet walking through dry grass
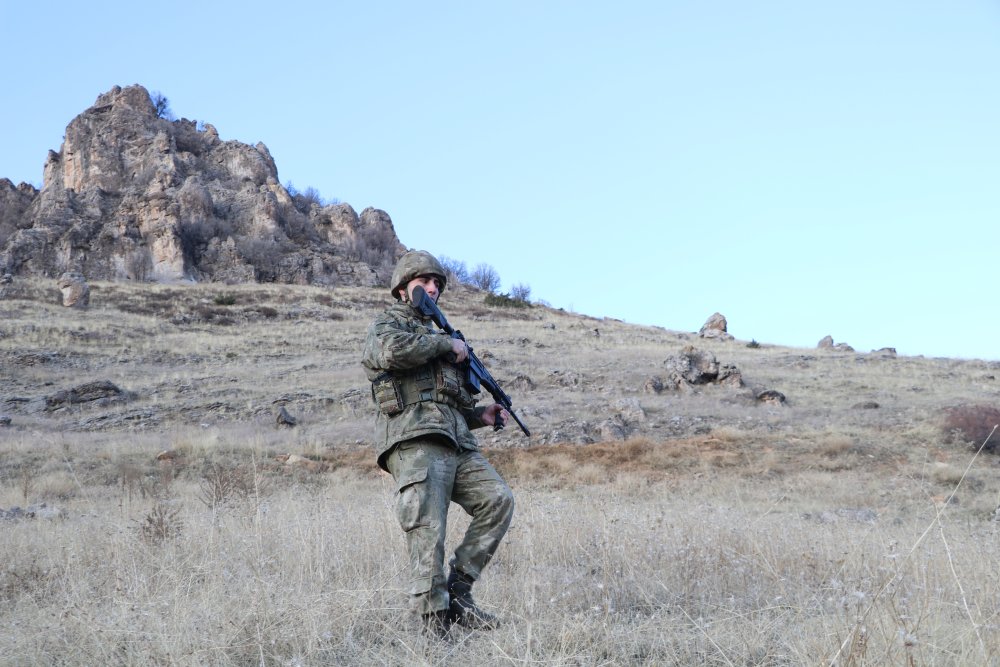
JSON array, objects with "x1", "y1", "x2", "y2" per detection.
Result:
[{"x1": 362, "y1": 250, "x2": 514, "y2": 636}]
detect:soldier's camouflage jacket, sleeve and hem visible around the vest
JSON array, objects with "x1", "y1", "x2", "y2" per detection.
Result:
[{"x1": 361, "y1": 302, "x2": 485, "y2": 470}]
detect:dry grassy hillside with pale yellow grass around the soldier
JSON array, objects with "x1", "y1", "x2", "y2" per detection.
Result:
[{"x1": 0, "y1": 281, "x2": 1000, "y2": 665}]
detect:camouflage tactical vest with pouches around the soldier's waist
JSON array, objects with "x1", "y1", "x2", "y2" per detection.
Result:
[{"x1": 372, "y1": 359, "x2": 476, "y2": 417}]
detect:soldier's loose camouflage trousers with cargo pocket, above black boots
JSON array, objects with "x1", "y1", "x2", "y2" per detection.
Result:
[{"x1": 385, "y1": 439, "x2": 514, "y2": 614}]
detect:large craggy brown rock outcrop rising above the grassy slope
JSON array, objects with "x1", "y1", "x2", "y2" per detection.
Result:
[{"x1": 0, "y1": 85, "x2": 404, "y2": 286}]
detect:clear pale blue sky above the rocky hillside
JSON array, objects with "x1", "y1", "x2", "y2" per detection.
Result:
[{"x1": 0, "y1": 0, "x2": 1000, "y2": 359}]
